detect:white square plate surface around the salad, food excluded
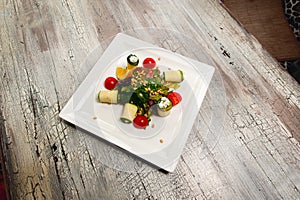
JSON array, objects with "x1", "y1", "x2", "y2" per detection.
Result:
[{"x1": 59, "y1": 33, "x2": 214, "y2": 172}]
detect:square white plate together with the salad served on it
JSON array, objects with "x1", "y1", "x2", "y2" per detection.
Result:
[{"x1": 59, "y1": 33, "x2": 214, "y2": 172}]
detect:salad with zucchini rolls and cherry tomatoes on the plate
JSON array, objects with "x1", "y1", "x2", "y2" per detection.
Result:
[{"x1": 98, "y1": 54, "x2": 184, "y2": 129}]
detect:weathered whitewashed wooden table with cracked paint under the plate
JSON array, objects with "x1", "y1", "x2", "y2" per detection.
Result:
[{"x1": 0, "y1": 0, "x2": 300, "y2": 199}]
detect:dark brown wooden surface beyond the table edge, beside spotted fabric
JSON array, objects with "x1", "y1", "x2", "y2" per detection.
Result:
[{"x1": 222, "y1": 0, "x2": 300, "y2": 61}]
